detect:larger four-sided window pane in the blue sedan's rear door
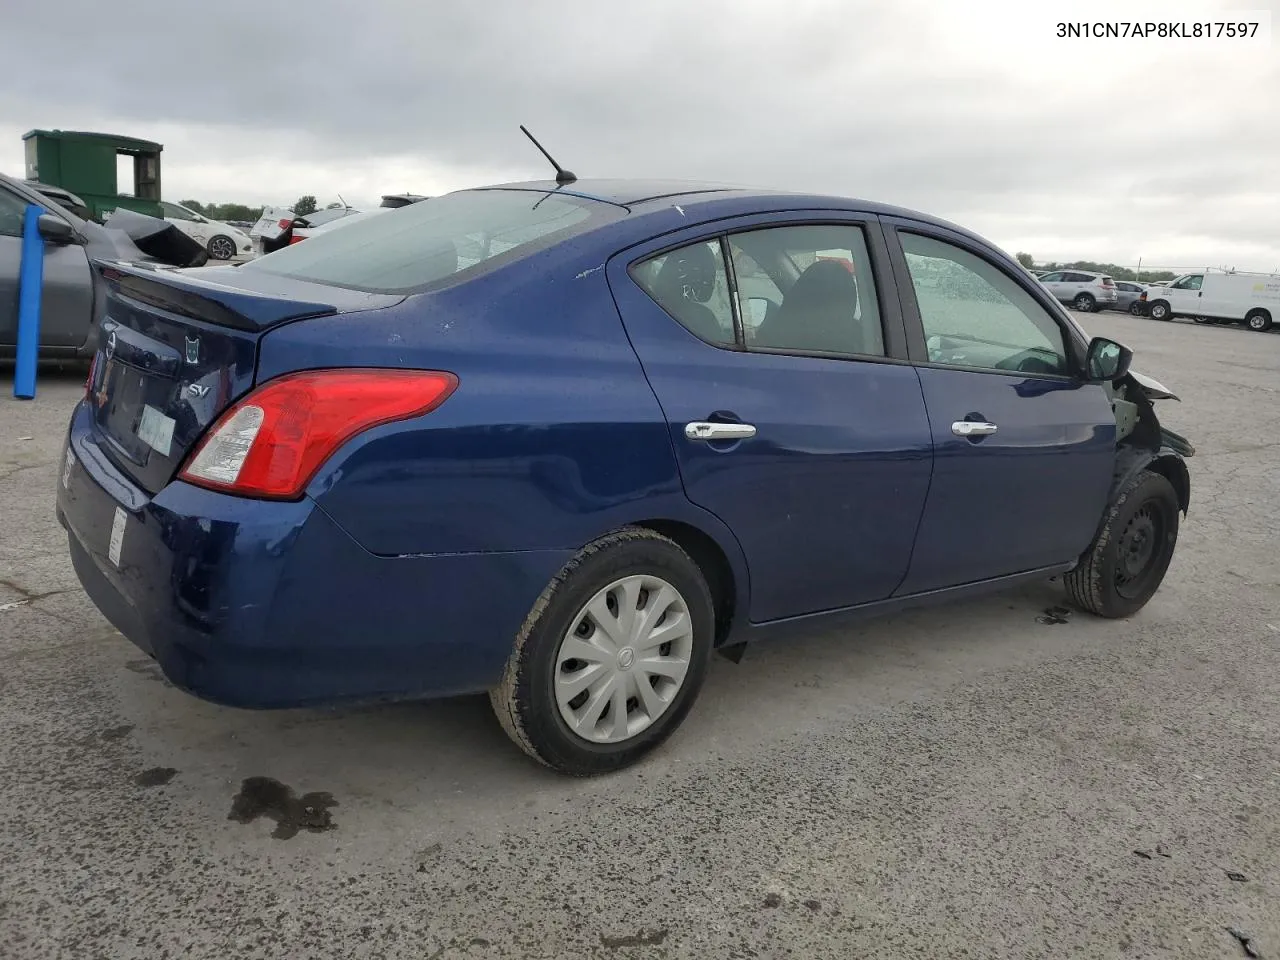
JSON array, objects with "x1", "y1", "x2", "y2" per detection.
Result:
[{"x1": 730, "y1": 224, "x2": 884, "y2": 356}]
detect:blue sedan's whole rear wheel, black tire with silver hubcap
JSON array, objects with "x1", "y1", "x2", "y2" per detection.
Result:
[{"x1": 489, "y1": 527, "x2": 716, "y2": 777}]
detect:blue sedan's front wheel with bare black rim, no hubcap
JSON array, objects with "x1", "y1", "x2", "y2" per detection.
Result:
[{"x1": 1062, "y1": 470, "x2": 1179, "y2": 618}]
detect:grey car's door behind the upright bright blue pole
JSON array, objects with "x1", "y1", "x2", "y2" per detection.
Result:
[{"x1": 0, "y1": 184, "x2": 93, "y2": 347}]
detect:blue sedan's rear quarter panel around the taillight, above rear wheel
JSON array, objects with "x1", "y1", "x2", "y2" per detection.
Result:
[{"x1": 259, "y1": 247, "x2": 745, "y2": 582}]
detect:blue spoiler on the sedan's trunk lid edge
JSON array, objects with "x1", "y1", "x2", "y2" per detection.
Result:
[{"x1": 93, "y1": 260, "x2": 343, "y2": 333}]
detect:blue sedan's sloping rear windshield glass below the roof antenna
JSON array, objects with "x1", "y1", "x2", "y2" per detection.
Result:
[{"x1": 239, "y1": 189, "x2": 623, "y2": 293}]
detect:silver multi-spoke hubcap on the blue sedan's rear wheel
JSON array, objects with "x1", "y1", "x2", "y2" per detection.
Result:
[{"x1": 556, "y1": 576, "x2": 694, "y2": 744}]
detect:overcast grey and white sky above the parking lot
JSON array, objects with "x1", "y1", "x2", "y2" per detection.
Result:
[{"x1": 0, "y1": 0, "x2": 1280, "y2": 270}]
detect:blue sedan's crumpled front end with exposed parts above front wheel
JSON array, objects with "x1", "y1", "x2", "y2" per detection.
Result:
[{"x1": 1106, "y1": 370, "x2": 1196, "y2": 516}]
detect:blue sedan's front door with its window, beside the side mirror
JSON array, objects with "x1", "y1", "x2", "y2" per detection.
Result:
[{"x1": 890, "y1": 220, "x2": 1116, "y2": 594}]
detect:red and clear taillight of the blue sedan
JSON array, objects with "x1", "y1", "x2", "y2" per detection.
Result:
[{"x1": 178, "y1": 370, "x2": 458, "y2": 499}]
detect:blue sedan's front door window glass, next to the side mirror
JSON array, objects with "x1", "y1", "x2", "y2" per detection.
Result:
[{"x1": 899, "y1": 233, "x2": 1070, "y2": 375}]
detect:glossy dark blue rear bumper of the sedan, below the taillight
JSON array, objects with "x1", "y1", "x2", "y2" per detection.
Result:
[{"x1": 58, "y1": 406, "x2": 570, "y2": 708}]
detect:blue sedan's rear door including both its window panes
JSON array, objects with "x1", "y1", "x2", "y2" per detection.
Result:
[{"x1": 608, "y1": 214, "x2": 932, "y2": 622}]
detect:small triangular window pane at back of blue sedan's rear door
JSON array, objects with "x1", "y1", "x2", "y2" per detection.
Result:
[{"x1": 632, "y1": 238, "x2": 735, "y2": 347}]
